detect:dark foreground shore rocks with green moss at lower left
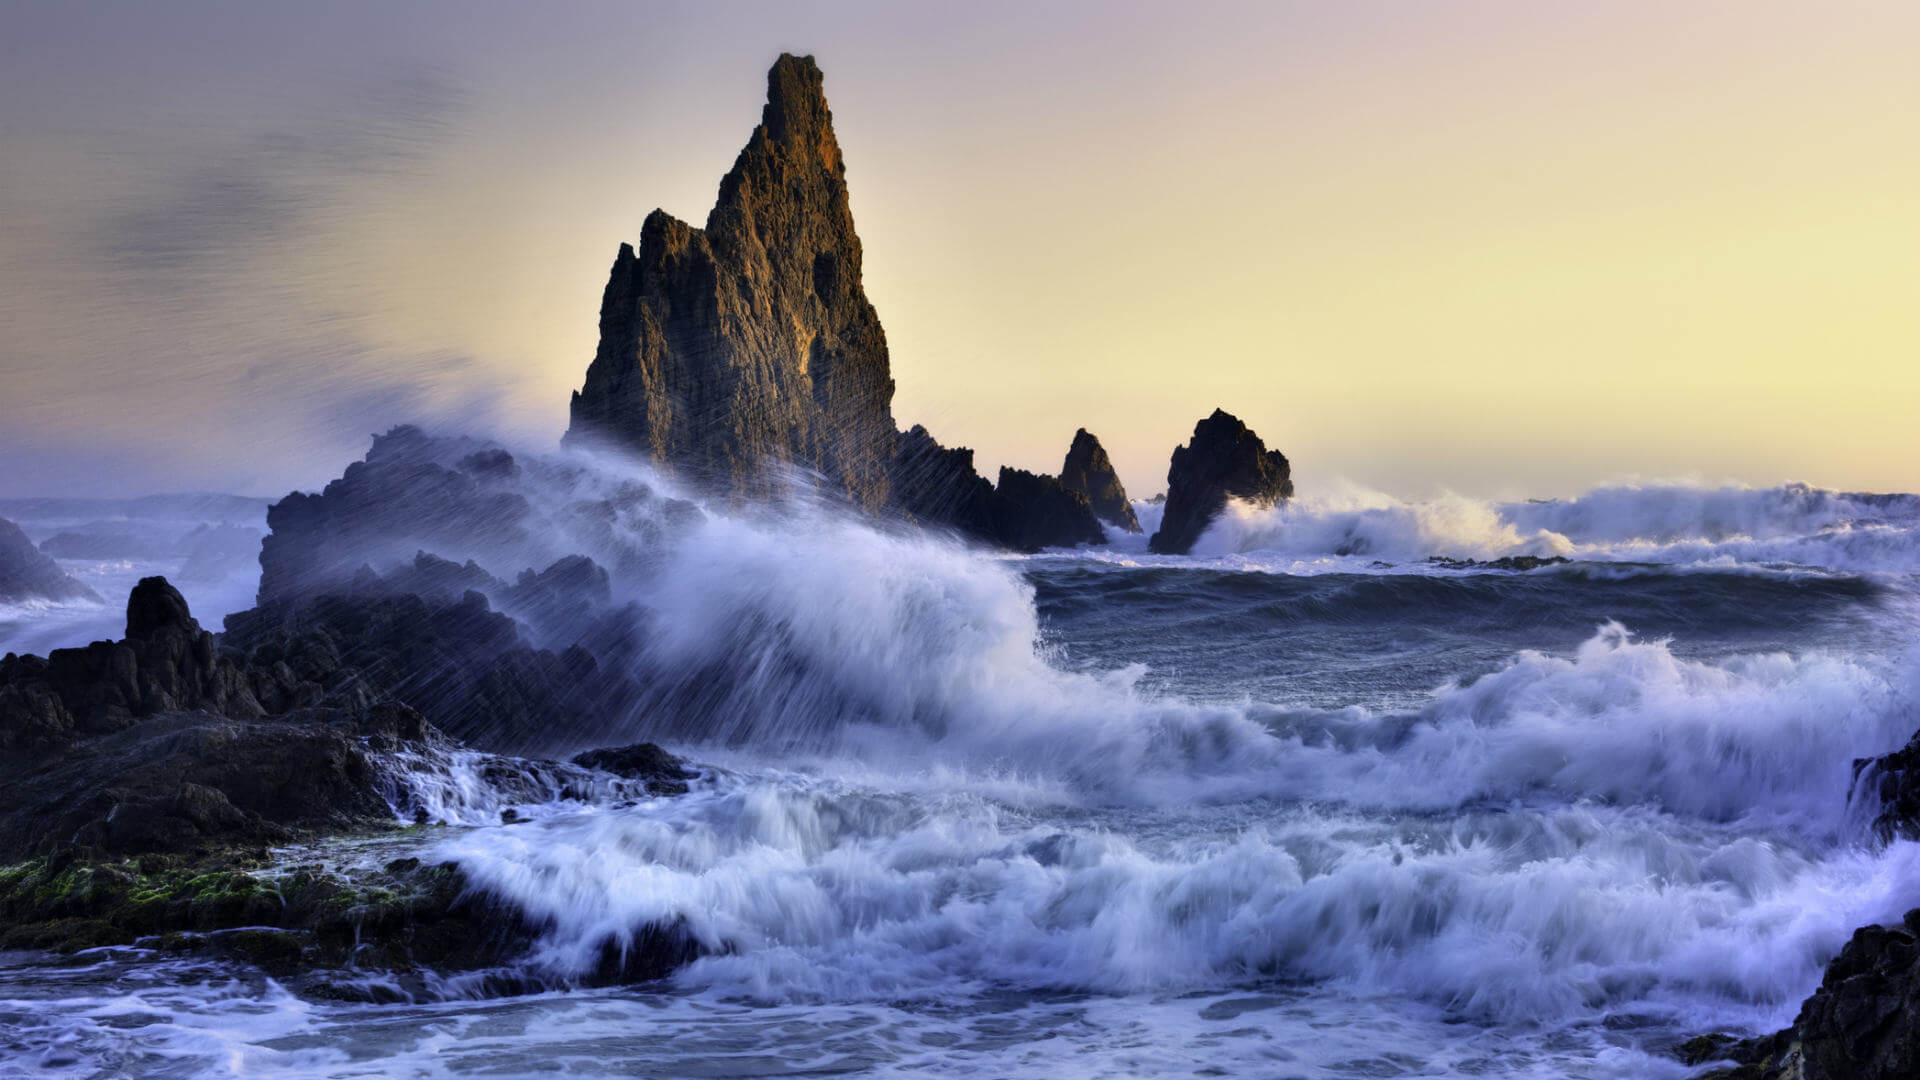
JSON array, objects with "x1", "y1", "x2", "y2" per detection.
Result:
[{"x1": 0, "y1": 578, "x2": 697, "y2": 999}]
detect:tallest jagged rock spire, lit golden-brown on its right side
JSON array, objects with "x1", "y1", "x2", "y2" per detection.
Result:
[{"x1": 568, "y1": 56, "x2": 895, "y2": 509}]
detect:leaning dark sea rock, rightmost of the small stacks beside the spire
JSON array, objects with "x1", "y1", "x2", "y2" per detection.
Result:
[{"x1": 1146, "y1": 409, "x2": 1294, "y2": 555}]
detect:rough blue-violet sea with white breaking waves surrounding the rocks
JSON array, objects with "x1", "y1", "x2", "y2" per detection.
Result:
[{"x1": 0, "y1": 474, "x2": 1920, "y2": 1080}]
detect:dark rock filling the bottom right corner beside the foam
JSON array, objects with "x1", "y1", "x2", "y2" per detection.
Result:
[{"x1": 1680, "y1": 909, "x2": 1920, "y2": 1080}]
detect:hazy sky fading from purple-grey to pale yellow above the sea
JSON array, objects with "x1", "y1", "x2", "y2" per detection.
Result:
[{"x1": 0, "y1": 0, "x2": 1920, "y2": 498}]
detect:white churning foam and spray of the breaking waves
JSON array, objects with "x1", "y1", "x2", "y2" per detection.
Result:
[{"x1": 0, "y1": 441, "x2": 1920, "y2": 1076}]
